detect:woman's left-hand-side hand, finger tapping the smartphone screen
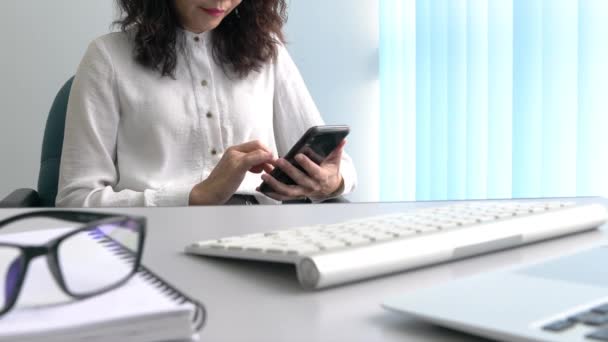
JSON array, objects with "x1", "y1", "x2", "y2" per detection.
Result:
[{"x1": 189, "y1": 141, "x2": 273, "y2": 205}]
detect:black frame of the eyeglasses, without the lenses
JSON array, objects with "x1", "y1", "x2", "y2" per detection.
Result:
[{"x1": 0, "y1": 210, "x2": 146, "y2": 316}]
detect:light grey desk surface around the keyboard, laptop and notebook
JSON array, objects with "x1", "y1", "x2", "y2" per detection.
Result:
[{"x1": 0, "y1": 198, "x2": 608, "y2": 342}]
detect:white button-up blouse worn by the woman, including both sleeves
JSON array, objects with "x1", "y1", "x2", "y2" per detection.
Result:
[{"x1": 56, "y1": 30, "x2": 357, "y2": 207}]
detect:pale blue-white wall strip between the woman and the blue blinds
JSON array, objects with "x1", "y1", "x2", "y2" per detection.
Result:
[{"x1": 287, "y1": 0, "x2": 380, "y2": 201}]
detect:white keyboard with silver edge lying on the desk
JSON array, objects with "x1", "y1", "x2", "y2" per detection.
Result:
[{"x1": 186, "y1": 201, "x2": 608, "y2": 289}]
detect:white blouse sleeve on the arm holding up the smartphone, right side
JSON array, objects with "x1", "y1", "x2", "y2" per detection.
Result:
[{"x1": 274, "y1": 45, "x2": 357, "y2": 194}]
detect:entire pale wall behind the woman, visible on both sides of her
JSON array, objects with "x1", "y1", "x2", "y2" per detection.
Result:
[{"x1": 0, "y1": 0, "x2": 379, "y2": 201}]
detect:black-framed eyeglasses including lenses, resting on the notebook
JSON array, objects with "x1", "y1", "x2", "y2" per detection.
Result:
[{"x1": 0, "y1": 210, "x2": 146, "y2": 316}]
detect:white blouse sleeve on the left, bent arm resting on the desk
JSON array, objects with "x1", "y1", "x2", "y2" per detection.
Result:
[{"x1": 56, "y1": 39, "x2": 194, "y2": 207}]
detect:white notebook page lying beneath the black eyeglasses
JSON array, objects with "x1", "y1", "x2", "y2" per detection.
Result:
[{"x1": 0, "y1": 230, "x2": 193, "y2": 340}]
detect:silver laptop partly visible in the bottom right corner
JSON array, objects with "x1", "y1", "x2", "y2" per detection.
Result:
[{"x1": 382, "y1": 245, "x2": 608, "y2": 342}]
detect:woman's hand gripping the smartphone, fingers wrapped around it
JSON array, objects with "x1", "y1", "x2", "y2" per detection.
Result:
[{"x1": 257, "y1": 140, "x2": 346, "y2": 201}]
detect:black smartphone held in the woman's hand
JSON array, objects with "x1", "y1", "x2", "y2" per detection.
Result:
[{"x1": 260, "y1": 125, "x2": 350, "y2": 193}]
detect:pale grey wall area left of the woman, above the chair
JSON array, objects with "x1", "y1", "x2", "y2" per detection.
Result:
[{"x1": 0, "y1": 0, "x2": 114, "y2": 197}]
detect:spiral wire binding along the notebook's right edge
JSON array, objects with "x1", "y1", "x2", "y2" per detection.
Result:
[{"x1": 90, "y1": 231, "x2": 207, "y2": 331}]
